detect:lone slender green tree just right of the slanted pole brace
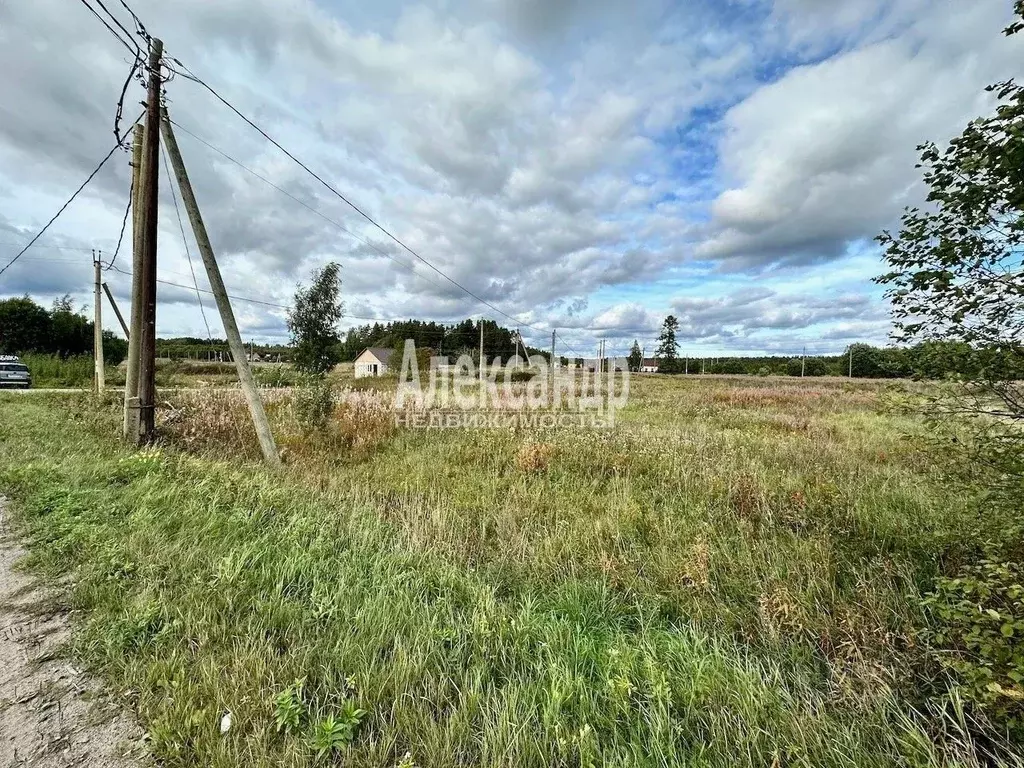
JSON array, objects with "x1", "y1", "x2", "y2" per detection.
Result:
[{"x1": 288, "y1": 261, "x2": 344, "y2": 376}]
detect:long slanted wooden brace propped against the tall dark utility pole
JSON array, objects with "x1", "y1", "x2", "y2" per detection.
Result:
[{"x1": 161, "y1": 109, "x2": 281, "y2": 469}]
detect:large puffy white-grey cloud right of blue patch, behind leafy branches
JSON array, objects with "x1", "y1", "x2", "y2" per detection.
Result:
[{"x1": 697, "y1": 3, "x2": 1020, "y2": 268}]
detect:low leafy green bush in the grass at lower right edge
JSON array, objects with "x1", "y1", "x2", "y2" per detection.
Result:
[{"x1": 922, "y1": 560, "x2": 1024, "y2": 739}]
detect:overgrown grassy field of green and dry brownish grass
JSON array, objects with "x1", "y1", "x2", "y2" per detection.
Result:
[{"x1": 0, "y1": 377, "x2": 1011, "y2": 768}]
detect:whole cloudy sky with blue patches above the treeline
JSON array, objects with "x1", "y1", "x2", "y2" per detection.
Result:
[{"x1": 0, "y1": 0, "x2": 1024, "y2": 355}]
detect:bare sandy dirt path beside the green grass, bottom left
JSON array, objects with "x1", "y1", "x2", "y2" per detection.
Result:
[{"x1": 0, "y1": 497, "x2": 148, "y2": 768}]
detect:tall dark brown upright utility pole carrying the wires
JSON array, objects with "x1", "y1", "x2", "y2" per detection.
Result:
[{"x1": 138, "y1": 38, "x2": 164, "y2": 443}]
